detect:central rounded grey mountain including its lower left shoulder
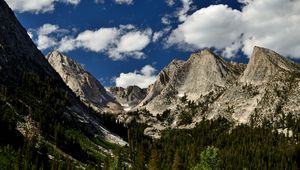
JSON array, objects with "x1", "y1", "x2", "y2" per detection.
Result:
[{"x1": 139, "y1": 50, "x2": 239, "y2": 114}]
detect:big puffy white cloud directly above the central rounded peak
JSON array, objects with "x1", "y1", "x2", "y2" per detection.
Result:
[{"x1": 168, "y1": 5, "x2": 242, "y2": 49}]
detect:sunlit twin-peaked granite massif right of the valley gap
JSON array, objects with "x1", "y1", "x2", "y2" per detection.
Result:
[{"x1": 128, "y1": 47, "x2": 300, "y2": 138}]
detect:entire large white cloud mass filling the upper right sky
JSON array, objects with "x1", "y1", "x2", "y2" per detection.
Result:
[{"x1": 166, "y1": 0, "x2": 300, "y2": 57}]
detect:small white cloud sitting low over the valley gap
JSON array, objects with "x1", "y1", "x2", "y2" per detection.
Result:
[{"x1": 115, "y1": 65, "x2": 156, "y2": 88}]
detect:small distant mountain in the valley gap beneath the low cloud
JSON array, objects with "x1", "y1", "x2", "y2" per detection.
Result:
[{"x1": 108, "y1": 86, "x2": 147, "y2": 111}]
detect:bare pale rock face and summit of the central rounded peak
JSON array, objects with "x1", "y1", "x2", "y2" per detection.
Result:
[{"x1": 179, "y1": 50, "x2": 237, "y2": 100}]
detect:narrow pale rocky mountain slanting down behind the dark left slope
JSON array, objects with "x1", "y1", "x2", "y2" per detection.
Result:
[{"x1": 47, "y1": 51, "x2": 122, "y2": 113}]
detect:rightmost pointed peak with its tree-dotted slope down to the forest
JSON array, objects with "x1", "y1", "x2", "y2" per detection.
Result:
[{"x1": 195, "y1": 47, "x2": 300, "y2": 123}]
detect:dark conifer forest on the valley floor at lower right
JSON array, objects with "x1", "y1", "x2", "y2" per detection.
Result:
[{"x1": 129, "y1": 117, "x2": 300, "y2": 169}]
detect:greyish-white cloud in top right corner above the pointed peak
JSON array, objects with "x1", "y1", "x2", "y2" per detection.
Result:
[{"x1": 243, "y1": 0, "x2": 300, "y2": 58}]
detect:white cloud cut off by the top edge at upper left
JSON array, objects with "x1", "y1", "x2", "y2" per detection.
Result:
[{"x1": 5, "y1": 0, "x2": 80, "y2": 13}]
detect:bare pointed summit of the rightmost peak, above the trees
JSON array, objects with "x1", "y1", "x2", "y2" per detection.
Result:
[{"x1": 240, "y1": 46, "x2": 299, "y2": 85}]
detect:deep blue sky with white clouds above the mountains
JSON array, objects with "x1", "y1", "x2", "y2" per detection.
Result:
[{"x1": 5, "y1": 0, "x2": 300, "y2": 88}]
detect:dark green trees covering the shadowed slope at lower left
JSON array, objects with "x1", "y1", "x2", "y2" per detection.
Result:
[{"x1": 0, "y1": 73, "x2": 127, "y2": 169}]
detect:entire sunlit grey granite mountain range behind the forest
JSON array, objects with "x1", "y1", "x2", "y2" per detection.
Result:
[{"x1": 48, "y1": 47, "x2": 300, "y2": 135}]
